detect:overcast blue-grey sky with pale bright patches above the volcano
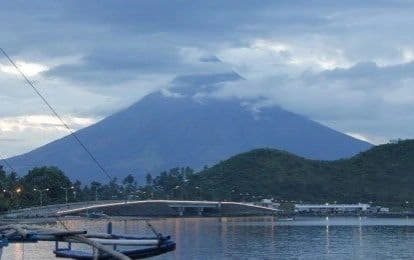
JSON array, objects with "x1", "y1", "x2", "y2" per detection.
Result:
[{"x1": 0, "y1": 0, "x2": 414, "y2": 156}]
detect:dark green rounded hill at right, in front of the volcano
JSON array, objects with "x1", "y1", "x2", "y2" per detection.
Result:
[{"x1": 197, "y1": 140, "x2": 414, "y2": 203}]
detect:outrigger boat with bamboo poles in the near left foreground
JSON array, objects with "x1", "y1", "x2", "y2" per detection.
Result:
[{"x1": 0, "y1": 222, "x2": 175, "y2": 260}]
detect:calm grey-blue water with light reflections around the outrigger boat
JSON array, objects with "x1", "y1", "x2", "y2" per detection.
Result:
[{"x1": 3, "y1": 217, "x2": 414, "y2": 260}]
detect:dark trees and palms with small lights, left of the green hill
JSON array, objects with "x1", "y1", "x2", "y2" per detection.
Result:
[{"x1": 0, "y1": 165, "x2": 200, "y2": 211}]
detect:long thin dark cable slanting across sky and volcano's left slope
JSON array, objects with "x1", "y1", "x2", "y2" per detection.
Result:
[{"x1": 0, "y1": 48, "x2": 112, "y2": 180}]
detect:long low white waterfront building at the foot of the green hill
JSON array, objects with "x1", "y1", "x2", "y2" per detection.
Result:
[{"x1": 295, "y1": 203, "x2": 370, "y2": 213}]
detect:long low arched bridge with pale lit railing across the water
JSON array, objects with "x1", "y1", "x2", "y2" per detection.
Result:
[{"x1": 3, "y1": 200, "x2": 280, "y2": 218}]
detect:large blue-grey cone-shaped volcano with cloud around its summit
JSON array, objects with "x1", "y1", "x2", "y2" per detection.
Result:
[{"x1": 10, "y1": 75, "x2": 371, "y2": 181}]
